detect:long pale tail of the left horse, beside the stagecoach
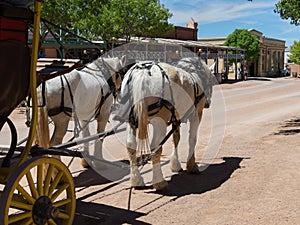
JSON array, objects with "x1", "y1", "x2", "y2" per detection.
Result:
[{"x1": 35, "y1": 85, "x2": 50, "y2": 148}]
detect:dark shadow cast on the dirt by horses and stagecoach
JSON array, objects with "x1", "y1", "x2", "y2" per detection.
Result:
[{"x1": 74, "y1": 157, "x2": 245, "y2": 225}]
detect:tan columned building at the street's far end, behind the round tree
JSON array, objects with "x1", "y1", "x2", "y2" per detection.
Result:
[{"x1": 198, "y1": 29, "x2": 286, "y2": 77}]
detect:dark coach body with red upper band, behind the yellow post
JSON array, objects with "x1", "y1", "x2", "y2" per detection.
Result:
[{"x1": 0, "y1": 4, "x2": 32, "y2": 127}]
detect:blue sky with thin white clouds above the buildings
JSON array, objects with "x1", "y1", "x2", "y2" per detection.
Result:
[{"x1": 160, "y1": 0, "x2": 300, "y2": 48}]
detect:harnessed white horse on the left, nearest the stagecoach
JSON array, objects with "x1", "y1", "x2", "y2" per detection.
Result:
[{"x1": 39, "y1": 56, "x2": 126, "y2": 167}]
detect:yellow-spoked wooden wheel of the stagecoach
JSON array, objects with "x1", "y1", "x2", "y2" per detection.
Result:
[{"x1": 0, "y1": 157, "x2": 76, "y2": 225}]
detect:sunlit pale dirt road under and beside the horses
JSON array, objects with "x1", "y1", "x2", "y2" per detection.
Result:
[{"x1": 2, "y1": 78, "x2": 300, "y2": 225}]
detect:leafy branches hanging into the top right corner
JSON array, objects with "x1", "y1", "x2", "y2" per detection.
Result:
[{"x1": 274, "y1": 0, "x2": 300, "y2": 26}]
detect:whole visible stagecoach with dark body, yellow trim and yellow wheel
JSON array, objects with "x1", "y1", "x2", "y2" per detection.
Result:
[{"x1": 0, "y1": 0, "x2": 76, "y2": 225}]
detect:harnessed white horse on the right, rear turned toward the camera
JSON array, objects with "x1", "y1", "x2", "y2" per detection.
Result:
[{"x1": 120, "y1": 58, "x2": 213, "y2": 190}]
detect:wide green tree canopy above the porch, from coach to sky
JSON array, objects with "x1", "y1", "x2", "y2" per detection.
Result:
[{"x1": 38, "y1": 0, "x2": 173, "y2": 40}]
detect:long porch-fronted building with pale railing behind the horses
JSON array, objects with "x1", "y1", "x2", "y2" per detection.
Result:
[{"x1": 29, "y1": 18, "x2": 245, "y2": 80}]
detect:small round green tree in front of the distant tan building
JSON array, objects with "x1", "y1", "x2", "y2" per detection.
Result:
[{"x1": 224, "y1": 29, "x2": 260, "y2": 61}]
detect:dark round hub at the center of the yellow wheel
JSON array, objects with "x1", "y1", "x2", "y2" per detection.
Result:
[{"x1": 32, "y1": 196, "x2": 59, "y2": 225}]
